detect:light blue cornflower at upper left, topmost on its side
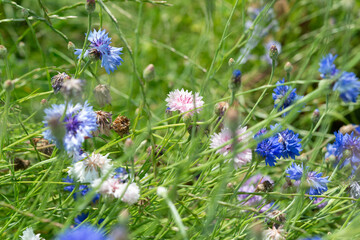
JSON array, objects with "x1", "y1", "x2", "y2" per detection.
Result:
[{"x1": 75, "y1": 29, "x2": 124, "y2": 74}]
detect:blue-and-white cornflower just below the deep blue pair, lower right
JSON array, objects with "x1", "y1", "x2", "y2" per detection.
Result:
[{"x1": 286, "y1": 163, "x2": 329, "y2": 199}]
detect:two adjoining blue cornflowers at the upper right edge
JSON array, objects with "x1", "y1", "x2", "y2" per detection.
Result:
[{"x1": 319, "y1": 53, "x2": 360, "y2": 102}]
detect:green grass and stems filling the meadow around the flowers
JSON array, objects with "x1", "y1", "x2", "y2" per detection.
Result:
[{"x1": 0, "y1": 0, "x2": 360, "y2": 239}]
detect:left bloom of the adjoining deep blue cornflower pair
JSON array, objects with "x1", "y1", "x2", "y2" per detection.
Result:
[{"x1": 254, "y1": 128, "x2": 283, "y2": 167}]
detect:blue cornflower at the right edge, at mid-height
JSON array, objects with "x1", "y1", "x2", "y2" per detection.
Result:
[{"x1": 325, "y1": 132, "x2": 360, "y2": 173}]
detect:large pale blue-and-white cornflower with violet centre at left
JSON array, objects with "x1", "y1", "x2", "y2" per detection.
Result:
[{"x1": 43, "y1": 102, "x2": 97, "y2": 155}]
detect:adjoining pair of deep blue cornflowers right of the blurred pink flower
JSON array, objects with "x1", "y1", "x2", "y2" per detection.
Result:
[{"x1": 254, "y1": 125, "x2": 302, "y2": 166}]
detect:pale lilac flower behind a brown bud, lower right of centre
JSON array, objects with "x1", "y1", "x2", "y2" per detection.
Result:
[{"x1": 237, "y1": 174, "x2": 272, "y2": 212}]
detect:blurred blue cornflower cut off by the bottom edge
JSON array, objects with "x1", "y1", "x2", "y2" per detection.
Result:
[{"x1": 56, "y1": 225, "x2": 109, "y2": 240}]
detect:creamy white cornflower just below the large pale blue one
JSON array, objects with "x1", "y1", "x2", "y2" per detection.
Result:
[{"x1": 69, "y1": 152, "x2": 112, "y2": 183}]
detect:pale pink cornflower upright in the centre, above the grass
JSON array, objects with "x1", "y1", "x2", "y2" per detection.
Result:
[{"x1": 165, "y1": 89, "x2": 204, "y2": 115}]
